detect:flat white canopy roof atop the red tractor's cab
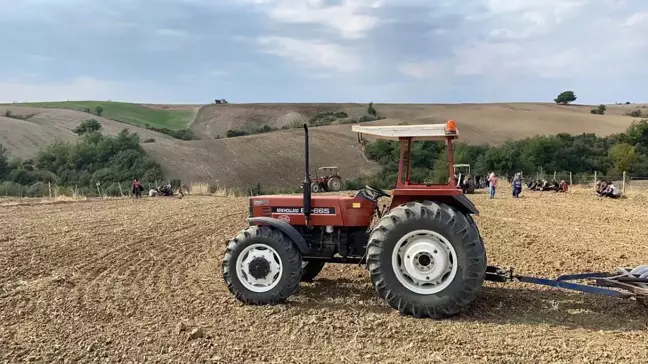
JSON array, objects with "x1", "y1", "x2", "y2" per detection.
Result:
[{"x1": 351, "y1": 124, "x2": 459, "y2": 140}]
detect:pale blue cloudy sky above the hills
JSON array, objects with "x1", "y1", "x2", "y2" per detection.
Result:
[{"x1": 0, "y1": 0, "x2": 648, "y2": 104}]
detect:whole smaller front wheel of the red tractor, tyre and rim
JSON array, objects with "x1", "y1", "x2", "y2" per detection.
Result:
[{"x1": 222, "y1": 226, "x2": 302, "y2": 305}]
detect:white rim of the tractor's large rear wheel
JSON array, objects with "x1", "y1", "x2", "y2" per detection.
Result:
[{"x1": 392, "y1": 230, "x2": 457, "y2": 295}]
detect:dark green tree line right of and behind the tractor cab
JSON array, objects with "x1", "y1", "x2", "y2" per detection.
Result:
[{"x1": 348, "y1": 119, "x2": 648, "y2": 189}]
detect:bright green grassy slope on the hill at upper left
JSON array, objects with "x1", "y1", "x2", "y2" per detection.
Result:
[{"x1": 4, "y1": 101, "x2": 198, "y2": 129}]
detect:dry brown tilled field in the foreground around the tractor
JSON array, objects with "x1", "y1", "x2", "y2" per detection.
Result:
[{"x1": 0, "y1": 190, "x2": 648, "y2": 363}]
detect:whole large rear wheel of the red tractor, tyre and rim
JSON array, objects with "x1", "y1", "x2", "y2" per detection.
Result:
[{"x1": 367, "y1": 201, "x2": 487, "y2": 319}]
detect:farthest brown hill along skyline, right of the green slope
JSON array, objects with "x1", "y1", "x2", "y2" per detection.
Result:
[{"x1": 191, "y1": 103, "x2": 648, "y2": 144}]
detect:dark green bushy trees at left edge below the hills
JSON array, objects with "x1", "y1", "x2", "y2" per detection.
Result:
[{"x1": 0, "y1": 119, "x2": 163, "y2": 197}]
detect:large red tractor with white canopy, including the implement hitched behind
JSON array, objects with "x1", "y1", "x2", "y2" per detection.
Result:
[{"x1": 222, "y1": 120, "x2": 648, "y2": 318}]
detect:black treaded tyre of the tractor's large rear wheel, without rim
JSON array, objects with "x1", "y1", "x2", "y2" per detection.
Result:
[{"x1": 367, "y1": 201, "x2": 487, "y2": 319}]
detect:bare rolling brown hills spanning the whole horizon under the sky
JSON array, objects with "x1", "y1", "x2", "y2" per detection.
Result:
[{"x1": 0, "y1": 101, "x2": 648, "y2": 187}]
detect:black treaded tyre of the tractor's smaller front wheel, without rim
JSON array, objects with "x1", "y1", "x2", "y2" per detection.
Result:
[{"x1": 222, "y1": 226, "x2": 302, "y2": 305}]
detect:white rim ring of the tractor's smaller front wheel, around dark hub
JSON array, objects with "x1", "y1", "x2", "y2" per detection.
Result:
[{"x1": 236, "y1": 244, "x2": 283, "y2": 293}]
